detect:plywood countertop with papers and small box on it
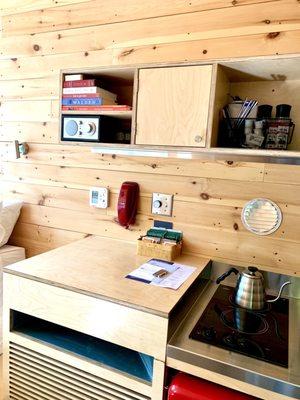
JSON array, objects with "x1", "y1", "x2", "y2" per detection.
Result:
[{"x1": 5, "y1": 236, "x2": 210, "y2": 317}]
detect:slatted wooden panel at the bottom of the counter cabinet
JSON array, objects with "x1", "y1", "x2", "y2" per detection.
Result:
[{"x1": 8, "y1": 335, "x2": 152, "y2": 400}]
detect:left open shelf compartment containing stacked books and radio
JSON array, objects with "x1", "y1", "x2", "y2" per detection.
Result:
[{"x1": 60, "y1": 67, "x2": 136, "y2": 144}]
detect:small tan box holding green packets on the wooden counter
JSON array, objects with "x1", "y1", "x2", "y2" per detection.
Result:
[{"x1": 137, "y1": 238, "x2": 182, "y2": 261}]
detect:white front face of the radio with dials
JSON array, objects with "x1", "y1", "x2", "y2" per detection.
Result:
[{"x1": 61, "y1": 116, "x2": 100, "y2": 141}]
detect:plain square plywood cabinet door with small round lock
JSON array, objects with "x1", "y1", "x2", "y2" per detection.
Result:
[{"x1": 135, "y1": 65, "x2": 212, "y2": 147}]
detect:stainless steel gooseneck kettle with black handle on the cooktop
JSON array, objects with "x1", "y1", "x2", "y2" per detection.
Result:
[{"x1": 216, "y1": 267, "x2": 291, "y2": 310}]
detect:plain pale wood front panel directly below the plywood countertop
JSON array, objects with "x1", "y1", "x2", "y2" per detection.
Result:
[{"x1": 4, "y1": 273, "x2": 168, "y2": 361}]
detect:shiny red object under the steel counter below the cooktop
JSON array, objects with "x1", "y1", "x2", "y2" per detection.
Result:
[{"x1": 167, "y1": 372, "x2": 257, "y2": 400}]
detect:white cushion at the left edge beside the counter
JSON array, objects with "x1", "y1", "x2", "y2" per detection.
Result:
[{"x1": 0, "y1": 200, "x2": 23, "y2": 247}]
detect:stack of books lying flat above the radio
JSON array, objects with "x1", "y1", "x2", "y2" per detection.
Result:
[{"x1": 62, "y1": 74, "x2": 131, "y2": 111}]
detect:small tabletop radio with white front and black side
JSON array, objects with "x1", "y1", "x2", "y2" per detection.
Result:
[{"x1": 61, "y1": 114, "x2": 120, "y2": 143}]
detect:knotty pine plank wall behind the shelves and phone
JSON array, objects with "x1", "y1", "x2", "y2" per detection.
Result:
[{"x1": 0, "y1": 0, "x2": 300, "y2": 273}]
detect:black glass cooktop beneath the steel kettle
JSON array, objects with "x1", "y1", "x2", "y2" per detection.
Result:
[{"x1": 189, "y1": 285, "x2": 289, "y2": 368}]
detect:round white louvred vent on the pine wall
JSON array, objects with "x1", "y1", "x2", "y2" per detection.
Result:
[{"x1": 242, "y1": 199, "x2": 282, "y2": 235}]
